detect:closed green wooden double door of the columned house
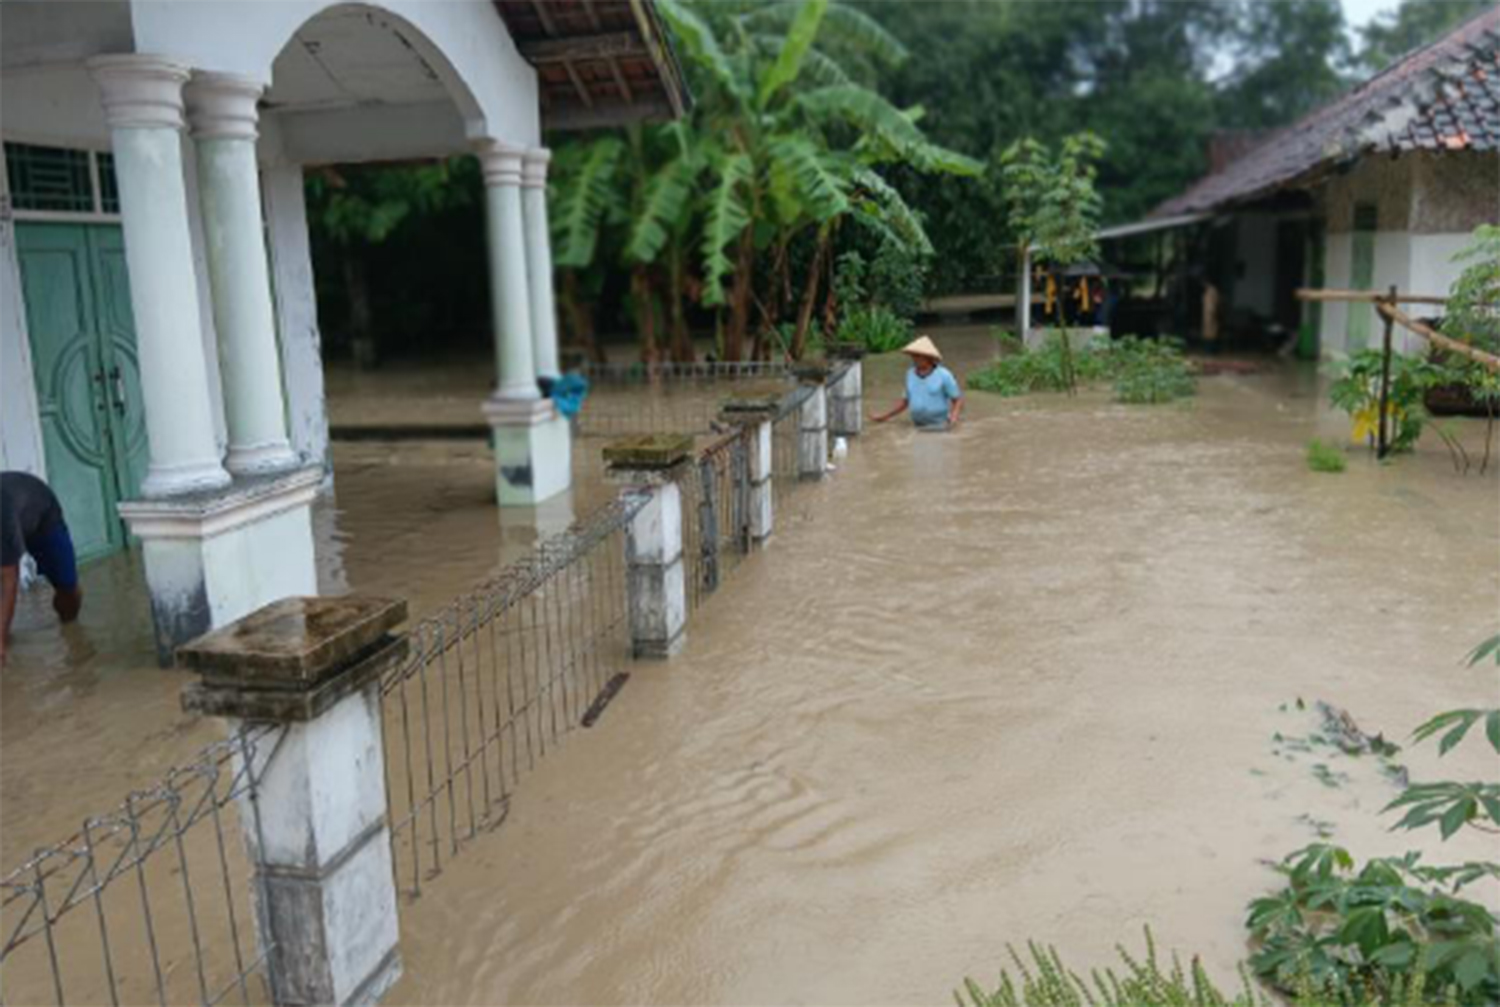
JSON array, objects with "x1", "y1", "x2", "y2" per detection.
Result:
[{"x1": 15, "y1": 224, "x2": 147, "y2": 558}]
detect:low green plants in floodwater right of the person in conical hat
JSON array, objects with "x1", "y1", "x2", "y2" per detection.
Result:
[{"x1": 969, "y1": 335, "x2": 1197, "y2": 405}]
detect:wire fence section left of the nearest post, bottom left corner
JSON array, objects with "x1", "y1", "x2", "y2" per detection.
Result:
[{"x1": 0, "y1": 726, "x2": 282, "y2": 1004}]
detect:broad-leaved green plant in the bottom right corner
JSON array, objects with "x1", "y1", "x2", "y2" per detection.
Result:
[{"x1": 1247, "y1": 636, "x2": 1500, "y2": 1004}]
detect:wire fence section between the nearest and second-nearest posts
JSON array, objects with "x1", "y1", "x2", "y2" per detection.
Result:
[{"x1": 381, "y1": 497, "x2": 642, "y2": 897}]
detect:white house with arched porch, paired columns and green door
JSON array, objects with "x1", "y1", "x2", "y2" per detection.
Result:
[{"x1": 0, "y1": 0, "x2": 686, "y2": 657}]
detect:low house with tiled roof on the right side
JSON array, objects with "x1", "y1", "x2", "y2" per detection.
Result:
[{"x1": 1074, "y1": 8, "x2": 1500, "y2": 357}]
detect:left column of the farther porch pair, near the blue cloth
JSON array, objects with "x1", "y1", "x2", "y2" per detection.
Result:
[{"x1": 479, "y1": 140, "x2": 542, "y2": 399}]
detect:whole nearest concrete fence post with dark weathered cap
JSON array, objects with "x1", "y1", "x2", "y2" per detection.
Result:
[{"x1": 177, "y1": 596, "x2": 408, "y2": 1005}]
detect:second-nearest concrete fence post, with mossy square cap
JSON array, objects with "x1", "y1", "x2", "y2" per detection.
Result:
[{"x1": 605, "y1": 434, "x2": 693, "y2": 660}]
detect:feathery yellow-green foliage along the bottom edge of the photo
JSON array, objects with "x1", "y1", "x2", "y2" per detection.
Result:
[{"x1": 954, "y1": 927, "x2": 1271, "y2": 1007}]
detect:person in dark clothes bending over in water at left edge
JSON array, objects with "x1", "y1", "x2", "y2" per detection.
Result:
[{"x1": 0, "y1": 473, "x2": 84, "y2": 663}]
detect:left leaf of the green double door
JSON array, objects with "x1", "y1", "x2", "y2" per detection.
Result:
[{"x1": 15, "y1": 224, "x2": 125, "y2": 558}]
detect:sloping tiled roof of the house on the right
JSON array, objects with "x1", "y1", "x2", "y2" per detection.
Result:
[{"x1": 1148, "y1": 6, "x2": 1500, "y2": 219}]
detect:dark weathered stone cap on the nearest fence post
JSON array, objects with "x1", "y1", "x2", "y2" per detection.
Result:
[{"x1": 177, "y1": 594, "x2": 408, "y2": 722}]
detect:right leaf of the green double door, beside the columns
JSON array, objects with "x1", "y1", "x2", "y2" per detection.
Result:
[{"x1": 89, "y1": 227, "x2": 150, "y2": 500}]
